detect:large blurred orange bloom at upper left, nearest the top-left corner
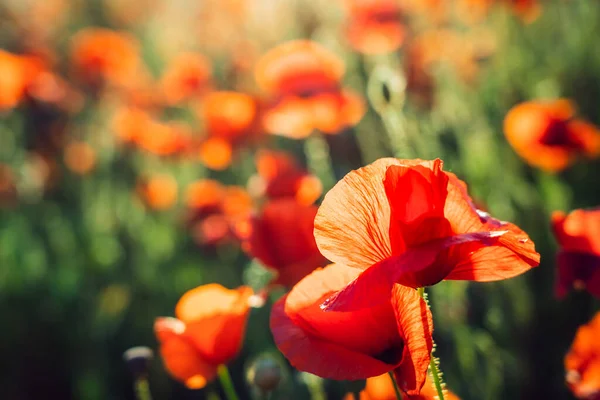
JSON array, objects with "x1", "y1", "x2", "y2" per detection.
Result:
[{"x1": 71, "y1": 28, "x2": 141, "y2": 88}]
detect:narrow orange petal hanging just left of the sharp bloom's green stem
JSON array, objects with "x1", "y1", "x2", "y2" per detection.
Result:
[{"x1": 392, "y1": 285, "x2": 433, "y2": 395}]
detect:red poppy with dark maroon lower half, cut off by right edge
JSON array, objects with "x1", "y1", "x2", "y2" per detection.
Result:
[{"x1": 552, "y1": 208, "x2": 600, "y2": 297}]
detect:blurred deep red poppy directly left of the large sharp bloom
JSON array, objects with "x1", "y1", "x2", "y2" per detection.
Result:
[{"x1": 242, "y1": 199, "x2": 326, "y2": 287}]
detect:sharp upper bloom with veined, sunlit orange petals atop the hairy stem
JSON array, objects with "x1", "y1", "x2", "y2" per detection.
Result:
[{"x1": 315, "y1": 158, "x2": 540, "y2": 310}]
